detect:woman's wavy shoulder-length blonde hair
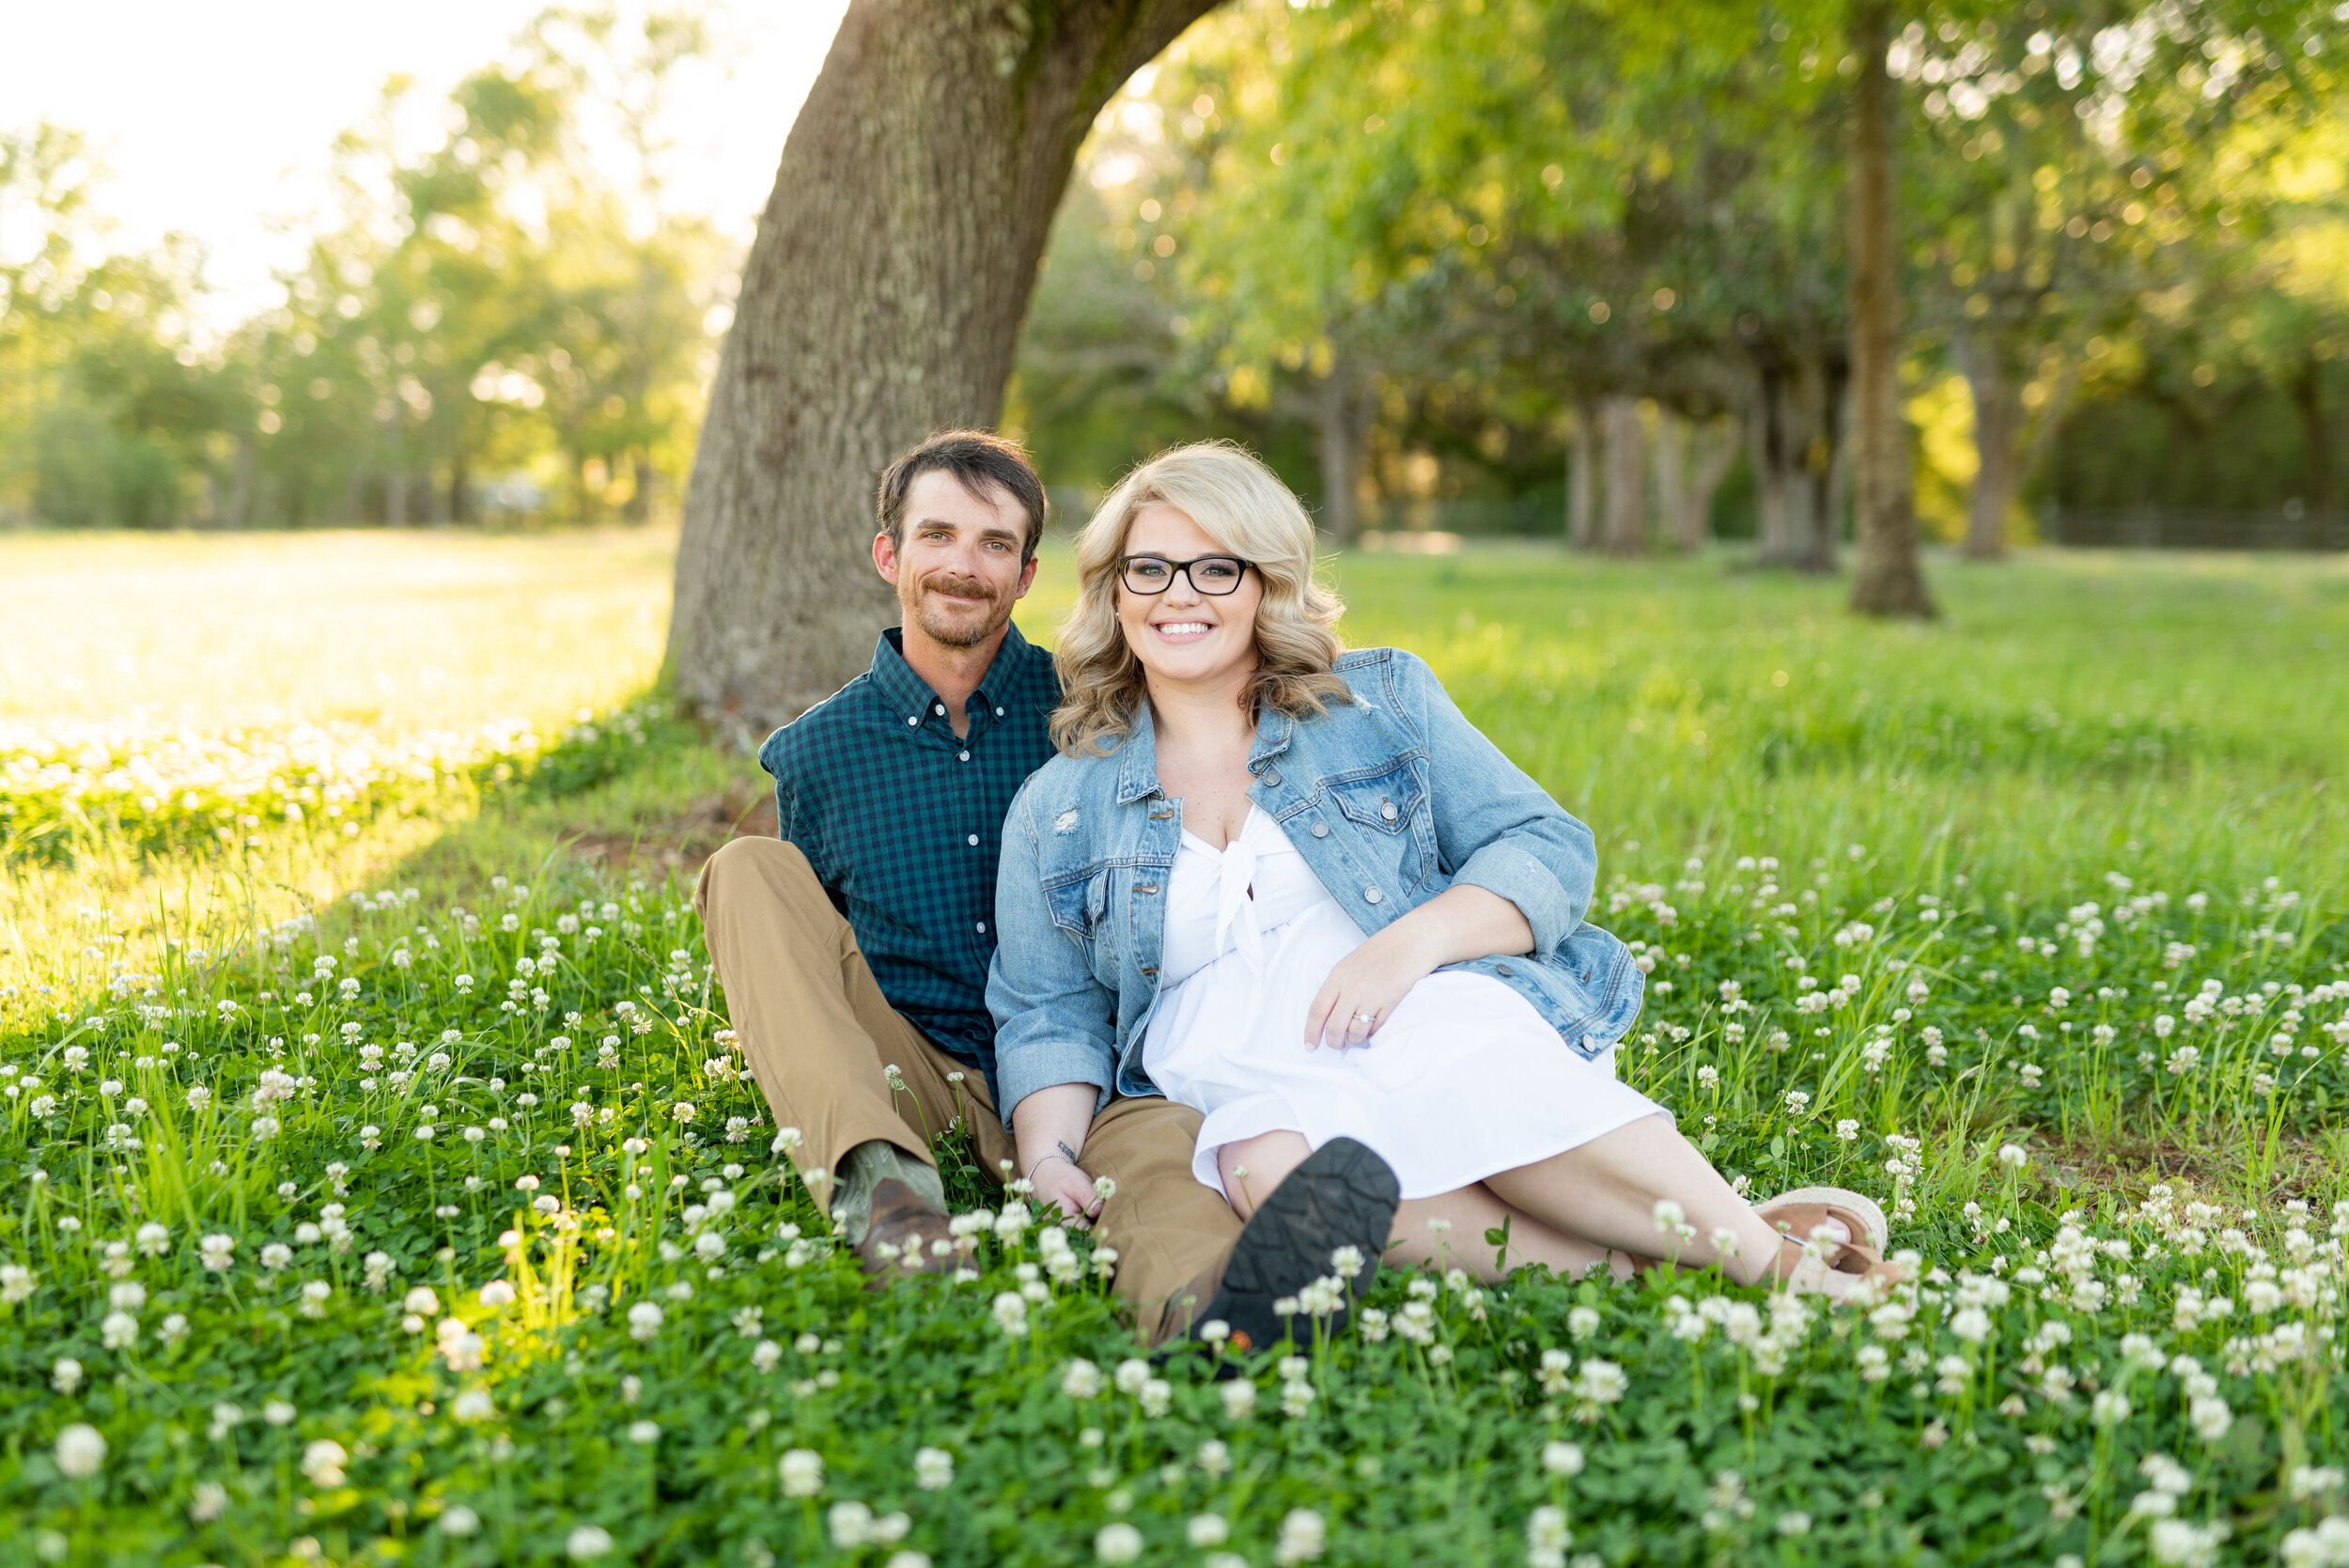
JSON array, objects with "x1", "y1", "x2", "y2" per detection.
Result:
[{"x1": 1052, "y1": 442, "x2": 1351, "y2": 756}]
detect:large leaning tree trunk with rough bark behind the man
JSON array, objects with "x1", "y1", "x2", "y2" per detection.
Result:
[{"x1": 667, "y1": 0, "x2": 1215, "y2": 735}]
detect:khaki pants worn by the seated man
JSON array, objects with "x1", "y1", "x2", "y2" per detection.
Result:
[{"x1": 693, "y1": 838, "x2": 1240, "y2": 1336}]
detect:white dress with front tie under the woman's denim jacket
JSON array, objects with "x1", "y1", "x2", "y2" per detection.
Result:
[{"x1": 1142, "y1": 807, "x2": 1663, "y2": 1197}]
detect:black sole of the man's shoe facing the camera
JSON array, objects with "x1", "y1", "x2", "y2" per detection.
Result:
[{"x1": 1191, "y1": 1139, "x2": 1403, "y2": 1350}]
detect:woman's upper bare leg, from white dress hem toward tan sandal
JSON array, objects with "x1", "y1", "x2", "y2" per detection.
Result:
[{"x1": 1485, "y1": 1115, "x2": 1859, "y2": 1298}]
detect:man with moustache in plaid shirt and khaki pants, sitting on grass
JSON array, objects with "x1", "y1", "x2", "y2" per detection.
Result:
[{"x1": 695, "y1": 429, "x2": 1395, "y2": 1345}]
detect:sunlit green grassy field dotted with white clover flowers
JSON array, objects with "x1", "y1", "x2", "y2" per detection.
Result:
[{"x1": 0, "y1": 536, "x2": 2349, "y2": 1568}]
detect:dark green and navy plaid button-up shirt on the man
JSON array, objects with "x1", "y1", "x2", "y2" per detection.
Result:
[{"x1": 759, "y1": 627, "x2": 1060, "y2": 1094}]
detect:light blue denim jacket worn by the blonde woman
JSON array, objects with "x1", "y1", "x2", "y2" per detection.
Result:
[{"x1": 987, "y1": 648, "x2": 1644, "y2": 1126}]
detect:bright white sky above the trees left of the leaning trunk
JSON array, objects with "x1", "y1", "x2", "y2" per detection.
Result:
[{"x1": 0, "y1": 0, "x2": 848, "y2": 329}]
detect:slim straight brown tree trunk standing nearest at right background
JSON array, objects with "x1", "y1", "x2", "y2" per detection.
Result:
[{"x1": 1851, "y1": 0, "x2": 1934, "y2": 615}]
